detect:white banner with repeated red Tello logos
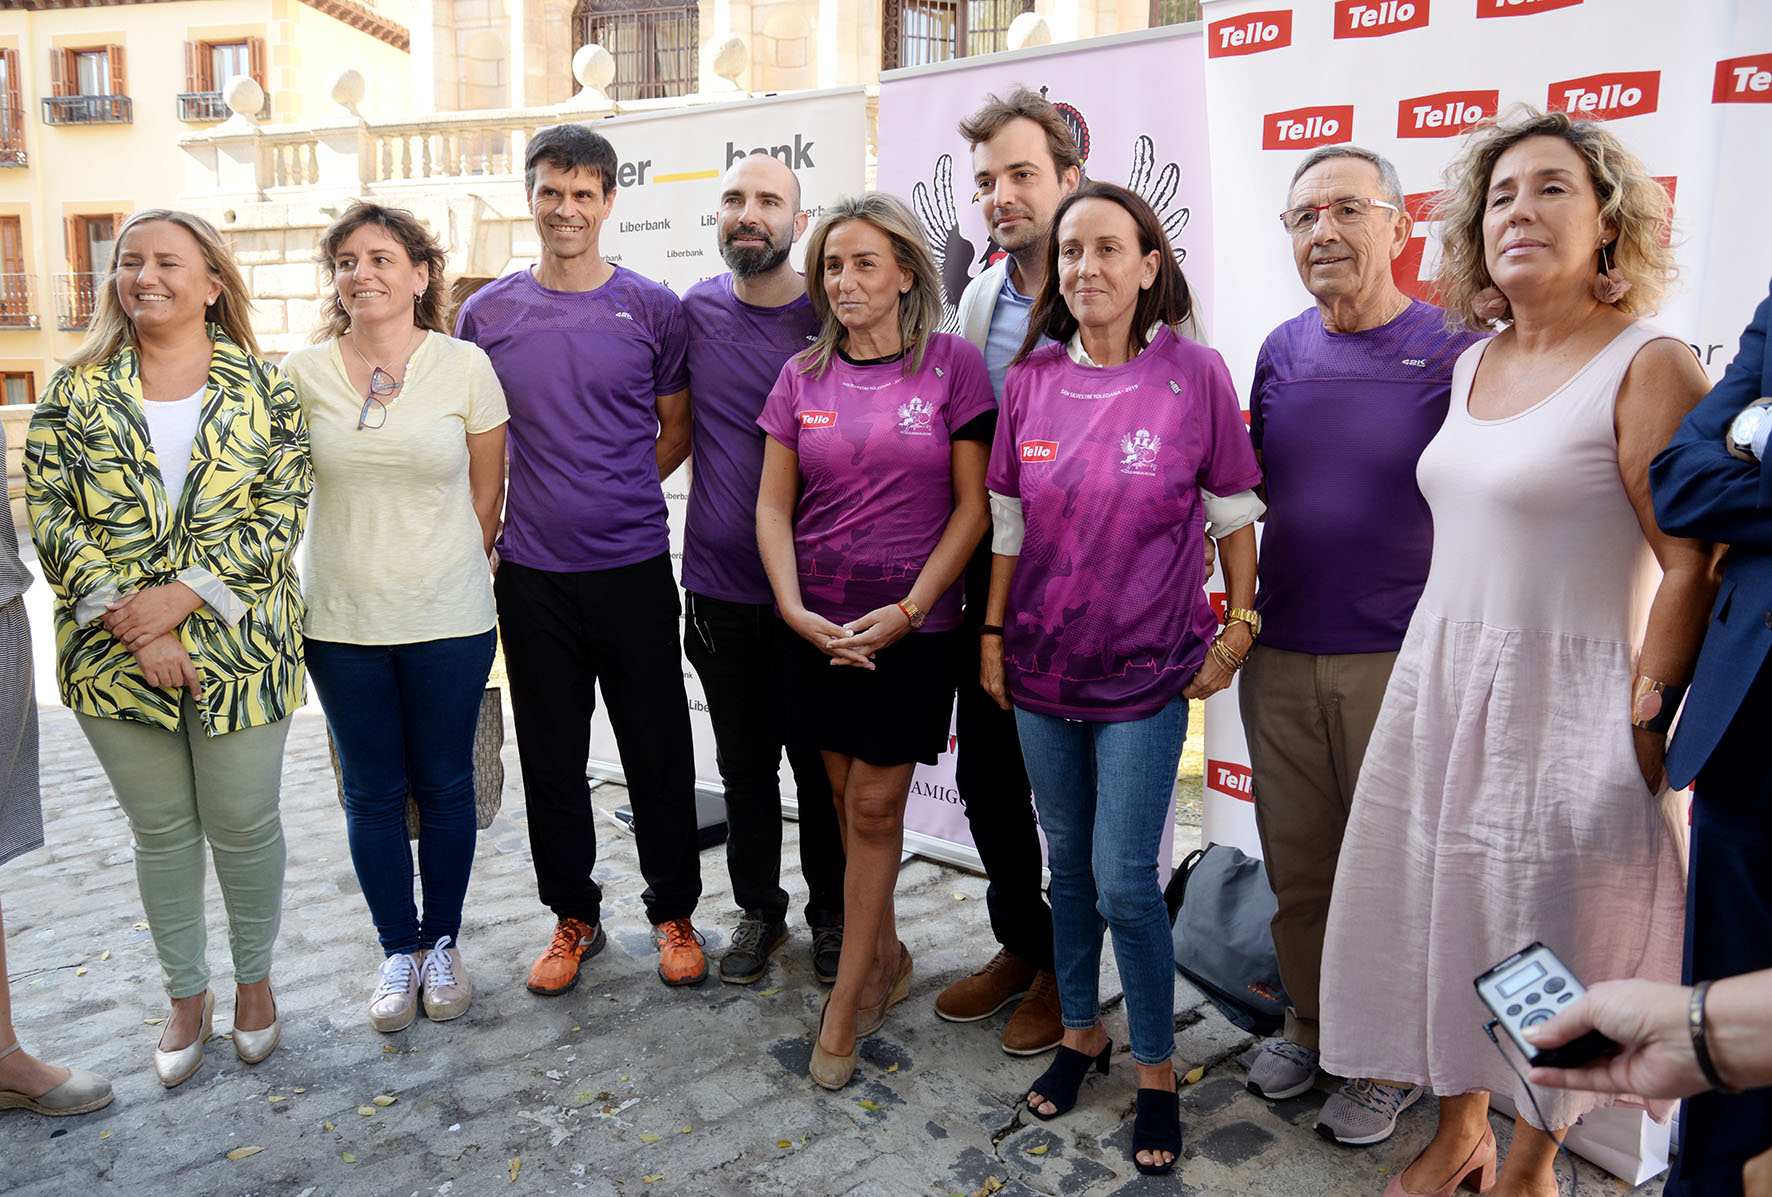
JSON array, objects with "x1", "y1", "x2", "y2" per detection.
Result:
[{"x1": 1203, "y1": 0, "x2": 1772, "y2": 1185}]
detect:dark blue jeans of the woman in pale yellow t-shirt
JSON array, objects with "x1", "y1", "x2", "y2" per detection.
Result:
[{"x1": 308, "y1": 629, "x2": 498, "y2": 956}]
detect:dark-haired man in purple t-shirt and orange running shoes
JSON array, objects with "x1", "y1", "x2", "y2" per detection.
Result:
[{"x1": 455, "y1": 124, "x2": 707, "y2": 995}]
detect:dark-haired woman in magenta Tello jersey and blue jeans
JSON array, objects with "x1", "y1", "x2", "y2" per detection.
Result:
[{"x1": 982, "y1": 182, "x2": 1262, "y2": 1172}]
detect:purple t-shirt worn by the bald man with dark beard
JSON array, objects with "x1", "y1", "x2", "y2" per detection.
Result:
[{"x1": 682, "y1": 274, "x2": 818, "y2": 604}]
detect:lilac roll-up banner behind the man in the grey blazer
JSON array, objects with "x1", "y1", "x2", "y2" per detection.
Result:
[{"x1": 877, "y1": 25, "x2": 1216, "y2": 877}]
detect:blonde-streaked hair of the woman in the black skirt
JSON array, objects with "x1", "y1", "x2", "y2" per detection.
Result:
[{"x1": 797, "y1": 191, "x2": 941, "y2": 377}]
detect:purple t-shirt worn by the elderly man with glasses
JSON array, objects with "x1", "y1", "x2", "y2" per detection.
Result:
[{"x1": 1249, "y1": 299, "x2": 1481, "y2": 653}]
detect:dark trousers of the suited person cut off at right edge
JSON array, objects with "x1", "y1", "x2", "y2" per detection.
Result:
[{"x1": 1666, "y1": 658, "x2": 1772, "y2": 1197}]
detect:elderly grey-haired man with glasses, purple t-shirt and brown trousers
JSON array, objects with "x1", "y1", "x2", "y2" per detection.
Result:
[{"x1": 1239, "y1": 145, "x2": 1478, "y2": 1144}]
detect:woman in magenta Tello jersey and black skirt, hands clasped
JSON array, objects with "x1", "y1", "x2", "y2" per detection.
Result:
[{"x1": 757, "y1": 193, "x2": 996, "y2": 1089}]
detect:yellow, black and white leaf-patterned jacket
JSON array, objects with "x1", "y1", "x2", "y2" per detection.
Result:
[{"x1": 25, "y1": 324, "x2": 314, "y2": 735}]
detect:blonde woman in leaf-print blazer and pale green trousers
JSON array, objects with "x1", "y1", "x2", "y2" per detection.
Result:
[{"x1": 25, "y1": 209, "x2": 314, "y2": 1089}]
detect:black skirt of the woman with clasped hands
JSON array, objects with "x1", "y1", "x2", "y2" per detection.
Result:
[{"x1": 778, "y1": 623, "x2": 964, "y2": 768}]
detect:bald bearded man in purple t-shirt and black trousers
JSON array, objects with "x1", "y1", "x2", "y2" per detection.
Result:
[{"x1": 682, "y1": 154, "x2": 843, "y2": 985}]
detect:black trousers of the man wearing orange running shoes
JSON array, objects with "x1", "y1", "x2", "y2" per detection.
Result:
[{"x1": 493, "y1": 554, "x2": 702, "y2": 924}]
